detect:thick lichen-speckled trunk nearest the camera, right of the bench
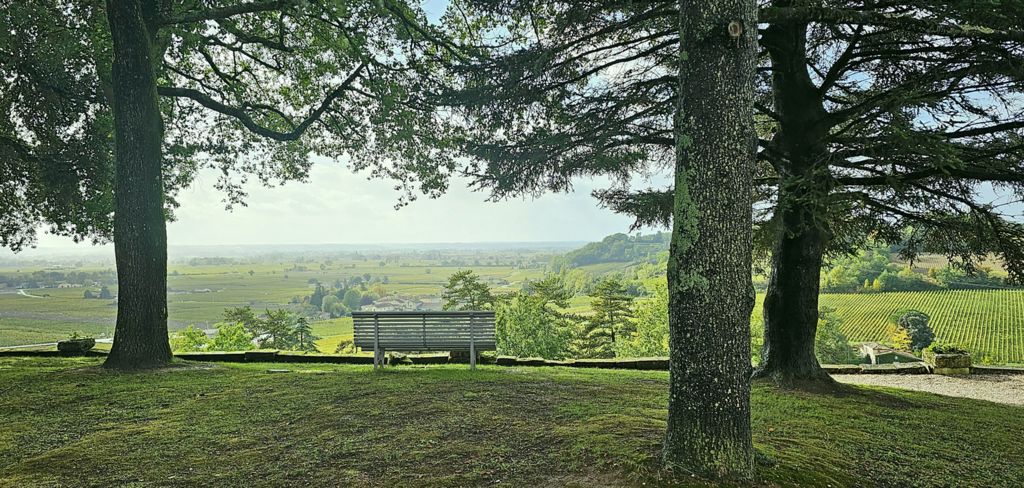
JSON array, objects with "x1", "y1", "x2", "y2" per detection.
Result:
[{"x1": 663, "y1": 0, "x2": 757, "y2": 478}]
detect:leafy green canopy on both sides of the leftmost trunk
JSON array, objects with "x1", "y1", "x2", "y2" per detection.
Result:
[{"x1": 0, "y1": 0, "x2": 454, "y2": 250}]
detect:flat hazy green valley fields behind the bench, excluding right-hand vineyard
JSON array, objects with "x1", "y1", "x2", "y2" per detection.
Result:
[{"x1": 0, "y1": 252, "x2": 544, "y2": 352}]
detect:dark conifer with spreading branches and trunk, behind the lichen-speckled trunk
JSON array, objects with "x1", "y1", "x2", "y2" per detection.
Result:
[{"x1": 432, "y1": 0, "x2": 1024, "y2": 386}]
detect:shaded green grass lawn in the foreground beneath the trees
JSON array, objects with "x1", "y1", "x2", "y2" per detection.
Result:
[{"x1": 0, "y1": 358, "x2": 1024, "y2": 487}]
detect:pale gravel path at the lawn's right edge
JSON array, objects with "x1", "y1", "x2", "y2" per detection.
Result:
[{"x1": 833, "y1": 374, "x2": 1024, "y2": 405}]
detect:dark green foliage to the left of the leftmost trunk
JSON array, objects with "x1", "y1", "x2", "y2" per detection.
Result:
[{"x1": 0, "y1": 0, "x2": 114, "y2": 251}]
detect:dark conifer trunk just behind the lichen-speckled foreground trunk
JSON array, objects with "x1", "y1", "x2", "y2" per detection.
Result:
[{"x1": 754, "y1": 9, "x2": 834, "y2": 388}]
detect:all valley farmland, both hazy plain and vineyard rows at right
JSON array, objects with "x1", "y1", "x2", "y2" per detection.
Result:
[{"x1": 0, "y1": 245, "x2": 1024, "y2": 363}]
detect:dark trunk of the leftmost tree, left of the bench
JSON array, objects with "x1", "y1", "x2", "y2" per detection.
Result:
[{"x1": 104, "y1": 0, "x2": 171, "y2": 368}]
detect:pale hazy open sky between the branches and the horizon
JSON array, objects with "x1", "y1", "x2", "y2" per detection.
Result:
[{"x1": 29, "y1": 159, "x2": 655, "y2": 247}]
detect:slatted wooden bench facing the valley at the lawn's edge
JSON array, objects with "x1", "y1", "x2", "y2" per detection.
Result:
[{"x1": 352, "y1": 311, "x2": 497, "y2": 369}]
